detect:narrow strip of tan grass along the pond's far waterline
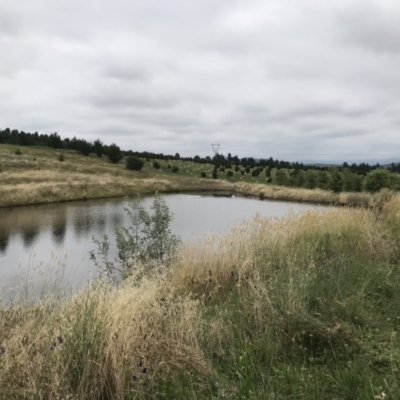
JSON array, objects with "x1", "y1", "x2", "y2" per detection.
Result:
[{"x1": 0, "y1": 176, "x2": 396, "y2": 209}]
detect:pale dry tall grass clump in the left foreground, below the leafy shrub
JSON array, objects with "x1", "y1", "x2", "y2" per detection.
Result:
[{"x1": 0, "y1": 278, "x2": 211, "y2": 399}]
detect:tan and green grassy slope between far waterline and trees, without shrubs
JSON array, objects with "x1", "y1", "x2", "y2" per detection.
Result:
[{"x1": 0, "y1": 145, "x2": 390, "y2": 207}]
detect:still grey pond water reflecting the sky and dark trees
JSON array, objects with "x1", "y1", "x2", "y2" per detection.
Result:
[{"x1": 0, "y1": 194, "x2": 324, "y2": 300}]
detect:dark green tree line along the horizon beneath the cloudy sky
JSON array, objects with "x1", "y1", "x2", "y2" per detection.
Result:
[{"x1": 0, "y1": 128, "x2": 400, "y2": 187}]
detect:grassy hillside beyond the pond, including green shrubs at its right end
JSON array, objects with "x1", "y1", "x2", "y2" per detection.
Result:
[{"x1": 0, "y1": 144, "x2": 398, "y2": 207}]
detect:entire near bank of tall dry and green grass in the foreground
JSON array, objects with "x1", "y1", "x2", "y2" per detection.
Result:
[{"x1": 0, "y1": 197, "x2": 400, "y2": 400}]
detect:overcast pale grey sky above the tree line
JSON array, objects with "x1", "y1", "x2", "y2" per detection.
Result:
[{"x1": 0, "y1": 0, "x2": 400, "y2": 162}]
